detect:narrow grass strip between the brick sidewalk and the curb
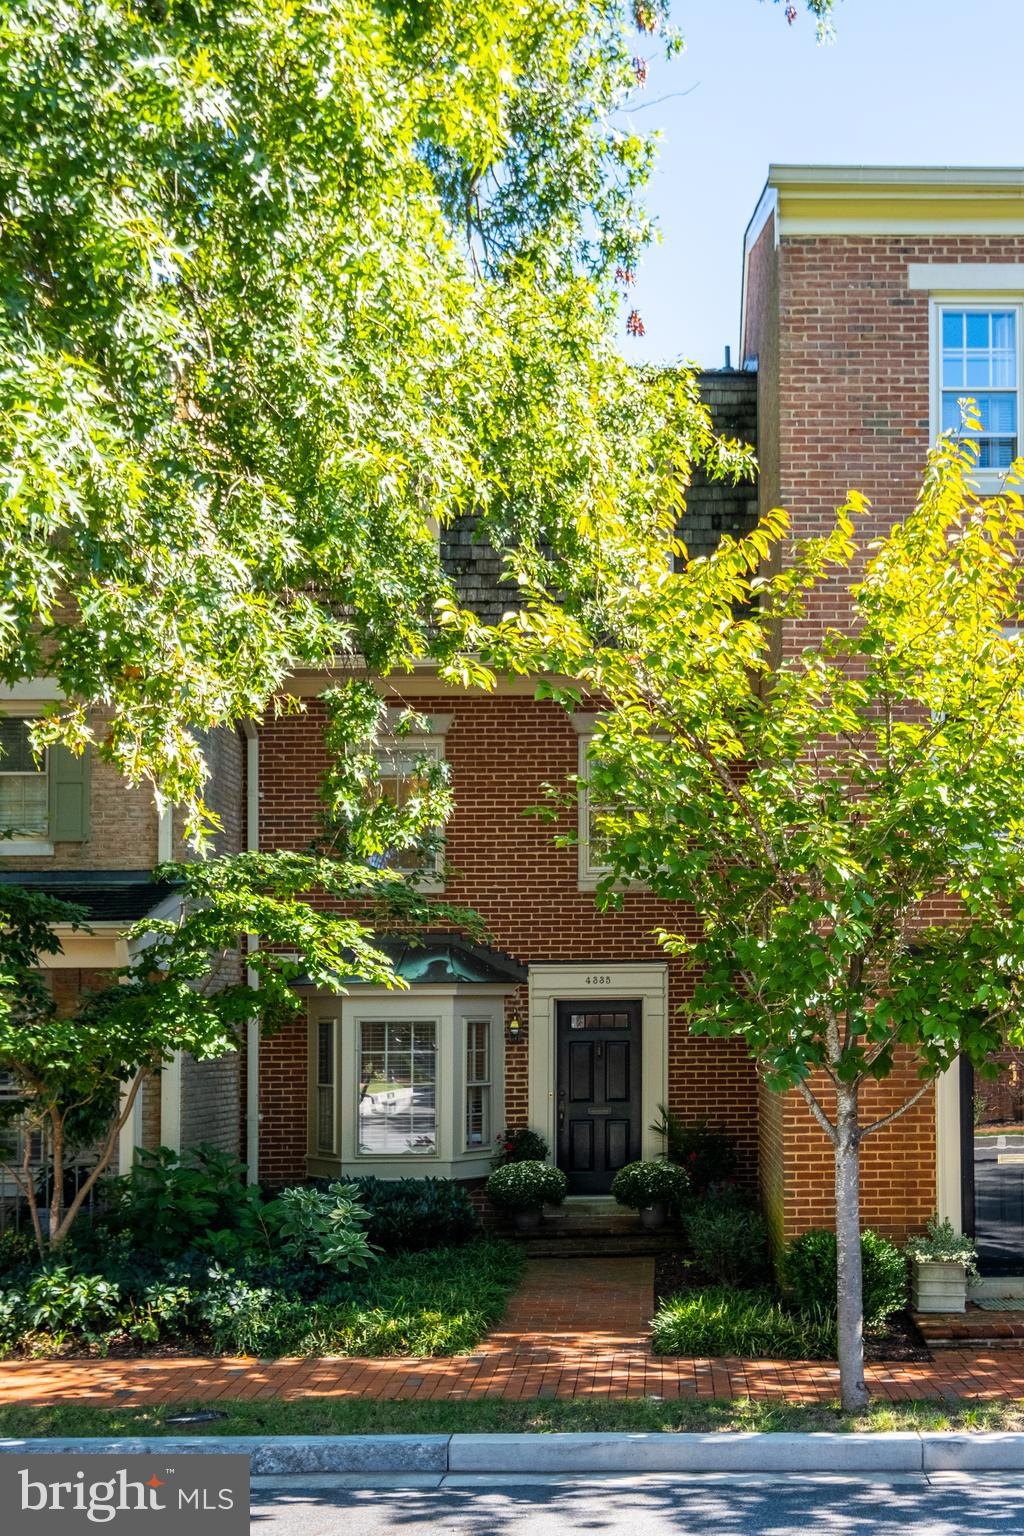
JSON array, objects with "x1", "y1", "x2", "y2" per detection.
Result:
[{"x1": 0, "y1": 1398, "x2": 1024, "y2": 1438}]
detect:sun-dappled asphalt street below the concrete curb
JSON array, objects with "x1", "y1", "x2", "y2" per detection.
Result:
[{"x1": 252, "y1": 1473, "x2": 1024, "y2": 1536}]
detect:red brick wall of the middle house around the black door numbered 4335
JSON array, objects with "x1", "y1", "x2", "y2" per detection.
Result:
[{"x1": 248, "y1": 694, "x2": 757, "y2": 1181}]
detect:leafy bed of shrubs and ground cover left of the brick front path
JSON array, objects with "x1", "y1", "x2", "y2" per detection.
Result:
[{"x1": 0, "y1": 1149, "x2": 522, "y2": 1358}]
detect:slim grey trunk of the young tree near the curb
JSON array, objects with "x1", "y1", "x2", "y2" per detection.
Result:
[{"x1": 835, "y1": 1087, "x2": 867, "y2": 1413}]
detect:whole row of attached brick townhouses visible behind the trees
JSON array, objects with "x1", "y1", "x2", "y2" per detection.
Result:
[{"x1": 0, "y1": 166, "x2": 1024, "y2": 1273}]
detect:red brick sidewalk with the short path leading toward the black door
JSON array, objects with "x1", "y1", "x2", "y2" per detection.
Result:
[{"x1": 0, "y1": 1258, "x2": 1024, "y2": 1407}]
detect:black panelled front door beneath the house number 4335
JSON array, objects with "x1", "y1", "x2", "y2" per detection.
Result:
[{"x1": 557, "y1": 1000, "x2": 642, "y2": 1195}]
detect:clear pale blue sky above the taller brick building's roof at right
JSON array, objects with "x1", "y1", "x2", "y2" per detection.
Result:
[{"x1": 622, "y1": 0, "x2": 1024, "y2": 367}]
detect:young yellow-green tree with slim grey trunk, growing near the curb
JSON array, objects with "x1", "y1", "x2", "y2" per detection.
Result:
[{"x1": 476, "y1": 439, "x2": 1024, "y2": 1407}]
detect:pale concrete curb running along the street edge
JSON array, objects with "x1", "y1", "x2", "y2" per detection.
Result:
[{"x1": 0, "y1": 1430, "x2": 1024, "y2": 1478}]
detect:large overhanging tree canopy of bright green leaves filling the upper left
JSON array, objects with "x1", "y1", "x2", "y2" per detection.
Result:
[{"x1": 0, "y1": 0, "x2": 841, "y2": 839}]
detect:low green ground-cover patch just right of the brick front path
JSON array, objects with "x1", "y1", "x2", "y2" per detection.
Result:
[{"x1": 651, "y1": 1287, "x2": 835, "y2": 1359}]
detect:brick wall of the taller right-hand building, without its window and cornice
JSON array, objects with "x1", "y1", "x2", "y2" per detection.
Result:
[{"x1": 742, "y1": 174, "x2": 1024, "y2": 1238}]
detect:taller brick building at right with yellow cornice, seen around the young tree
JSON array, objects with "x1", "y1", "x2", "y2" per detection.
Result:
[{"x1": 742, "y1": 166, "x2": 1024, "y2": 1270}]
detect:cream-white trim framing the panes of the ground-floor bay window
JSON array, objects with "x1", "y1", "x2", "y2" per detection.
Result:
[{"x1": 307, "y1": 986, "x2": 508, "y2": 1178}]
